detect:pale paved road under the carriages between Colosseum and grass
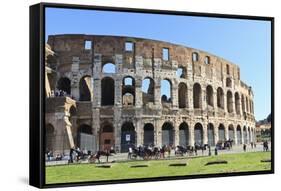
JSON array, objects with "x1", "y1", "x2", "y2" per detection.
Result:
[{"x1": 46, "y1": 143, "x2": 271, "y2": 166}]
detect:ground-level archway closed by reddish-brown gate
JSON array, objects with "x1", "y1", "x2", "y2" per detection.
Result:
[{"x1": 100, "y1": 123, "x2": 115, "y2": 151}]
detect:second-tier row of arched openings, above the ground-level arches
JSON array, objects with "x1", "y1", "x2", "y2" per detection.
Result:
[{"x1": 57, "y1": 76, "x2": 253, "y2": 114}]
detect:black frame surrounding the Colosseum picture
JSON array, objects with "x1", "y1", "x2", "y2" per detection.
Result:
[{"x1": 29, "y1": 3, "x2": 275, "y2": 188}]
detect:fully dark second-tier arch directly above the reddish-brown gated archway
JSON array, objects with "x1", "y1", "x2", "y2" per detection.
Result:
[{"x1": 101, "y1": 77, "x2": 115, "y2": 106}]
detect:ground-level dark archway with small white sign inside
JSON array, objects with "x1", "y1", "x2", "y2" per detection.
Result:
[{"x1": 121, "y1": 122, "x2": 136, "y2": 152}]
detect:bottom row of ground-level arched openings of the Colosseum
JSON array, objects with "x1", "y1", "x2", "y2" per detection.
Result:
[{"x1": 46, "y1": 121, "x2": 255, "y2": 152}]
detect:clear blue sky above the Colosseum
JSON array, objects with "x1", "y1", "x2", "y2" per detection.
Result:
[{"x1": 46, "y1": 8, "x2": 271, "y2": 120}]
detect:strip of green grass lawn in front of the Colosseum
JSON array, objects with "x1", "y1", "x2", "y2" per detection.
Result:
[{"x1": 46, "y1": 152, "x2": 271, "y2": 184}]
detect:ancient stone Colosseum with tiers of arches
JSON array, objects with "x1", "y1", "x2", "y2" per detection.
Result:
[{"x1": 45, "y1": 34, "x2": 256, "y2": 153}]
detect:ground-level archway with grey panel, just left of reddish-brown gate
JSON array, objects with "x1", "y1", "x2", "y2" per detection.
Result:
[{"x1": 76, "y1": 124, "x2": 95, "y2": 151}]
